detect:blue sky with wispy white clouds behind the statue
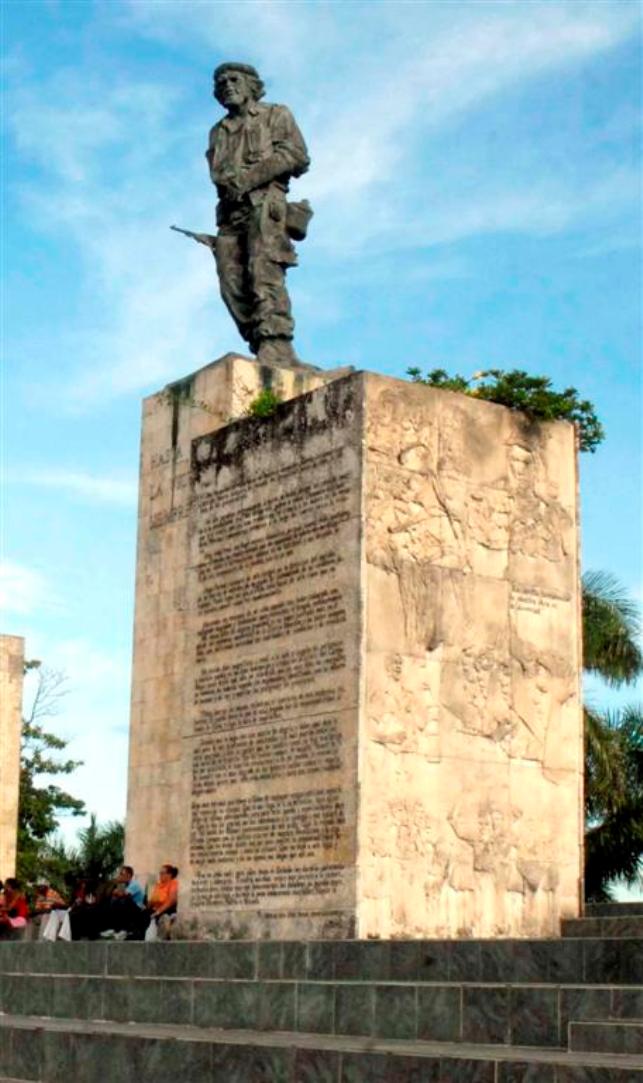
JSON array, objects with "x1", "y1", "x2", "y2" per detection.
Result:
[{"x1": 1, "y1": 0, "x2": 642, "y2": 840}]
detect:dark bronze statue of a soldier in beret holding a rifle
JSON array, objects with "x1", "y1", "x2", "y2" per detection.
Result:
[{"x1": 171, "y1": 63, "x2": 312, "y2": 366}]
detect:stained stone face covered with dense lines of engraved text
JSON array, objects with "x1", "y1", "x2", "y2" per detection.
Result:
[{"x1": 185, "y1": 380, "x2": 360, "y2": 935}]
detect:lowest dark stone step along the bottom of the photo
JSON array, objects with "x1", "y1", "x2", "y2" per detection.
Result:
[{"x1": 0, "y1": 1016, "x2": 643, "y2": 1083}]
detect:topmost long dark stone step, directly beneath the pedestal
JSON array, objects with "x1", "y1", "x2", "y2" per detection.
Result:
[{"x1": 0, "y1": 937, "x2": 643, "y2": 986}]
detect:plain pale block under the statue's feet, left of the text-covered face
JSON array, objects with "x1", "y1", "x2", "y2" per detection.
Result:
[{"x1": 127, "y1": 354, "x2": 346, "y2": 879}]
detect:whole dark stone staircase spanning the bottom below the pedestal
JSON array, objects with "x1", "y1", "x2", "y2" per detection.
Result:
[{"x1": 0, "y1": 911, "x2": 643, "y2": 1083}]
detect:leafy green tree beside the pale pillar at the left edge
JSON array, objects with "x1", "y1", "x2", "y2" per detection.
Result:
[{"x1": 16, "y1": 662, "x2": 84, "y2": 883}]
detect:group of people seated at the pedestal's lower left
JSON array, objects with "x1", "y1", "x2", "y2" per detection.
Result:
[{"x1": 0, "y1": 864, "x2": 179, "y2": 940}]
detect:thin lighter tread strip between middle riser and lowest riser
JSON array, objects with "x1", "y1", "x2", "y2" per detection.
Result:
[{"x1": 0, "y1": 1015, "x2": 643, "y2": 1077}]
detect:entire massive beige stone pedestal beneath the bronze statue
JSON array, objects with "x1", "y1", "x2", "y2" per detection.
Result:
[{"x1": 128, "y1": 360, "x2": 582, "y2": 938}]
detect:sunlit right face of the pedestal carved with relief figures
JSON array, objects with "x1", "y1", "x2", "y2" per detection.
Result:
[{"x1": 357, "y1": 375, "x2": 581, "y2": 937}]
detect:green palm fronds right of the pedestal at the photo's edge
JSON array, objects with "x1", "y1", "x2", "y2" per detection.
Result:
[{"x1": 582, "y1": 572, "x2": 643, "y2": 901}]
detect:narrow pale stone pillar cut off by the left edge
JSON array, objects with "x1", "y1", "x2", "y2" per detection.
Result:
[{"x1": 0, "y1": 636, "x2": 25, "y2": 879}]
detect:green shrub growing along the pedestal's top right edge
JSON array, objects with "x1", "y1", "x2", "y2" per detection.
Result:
[{"x1": 407, "y1": 368, "x2": 605, "y2": 452}]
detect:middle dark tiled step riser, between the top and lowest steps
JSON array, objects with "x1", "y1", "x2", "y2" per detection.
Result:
[{"x1": 0, "y1": 973, "x2": 643, "y2": 1047}]
